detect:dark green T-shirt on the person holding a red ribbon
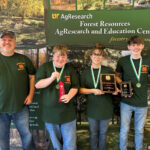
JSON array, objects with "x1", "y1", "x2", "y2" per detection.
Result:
[{"x1": 36, "y1": 62, "x2": 79, "y2": 124}]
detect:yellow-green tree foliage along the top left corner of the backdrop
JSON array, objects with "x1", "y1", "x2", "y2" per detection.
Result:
[{"x1": 0, "y1": 0, "x2": 44, "y2": 18}]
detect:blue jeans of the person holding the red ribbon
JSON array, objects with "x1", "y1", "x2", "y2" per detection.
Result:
[{"x1": 45, "y1": 120, "x2": 77, "y2": 150}]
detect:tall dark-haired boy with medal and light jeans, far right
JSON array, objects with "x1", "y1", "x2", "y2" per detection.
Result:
[{"x1": 116, "y1": 36, "x2": 150, "y2": 150}]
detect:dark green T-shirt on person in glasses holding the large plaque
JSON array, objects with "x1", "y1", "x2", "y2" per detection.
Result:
[{"x1": 80, "y1": 66, "x2": 113, "y2": 120}]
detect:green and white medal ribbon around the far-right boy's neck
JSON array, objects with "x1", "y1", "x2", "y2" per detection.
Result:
[{"x1": 130, "y1": 56, "x2": 142, "y2": 82}]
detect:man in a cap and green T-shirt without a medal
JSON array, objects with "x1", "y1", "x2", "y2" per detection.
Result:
[{"x1": 0, "y1": 31, "x2": 35, "y2": 150}]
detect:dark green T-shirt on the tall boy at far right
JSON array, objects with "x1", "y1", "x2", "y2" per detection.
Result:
[{"x1": 116, "y1": 56, "x2": 150, "y2": 107}]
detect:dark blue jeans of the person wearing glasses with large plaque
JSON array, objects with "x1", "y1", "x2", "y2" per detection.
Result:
[{"x1": 88, "y1": 118, "x2": 110, "y2": 150}]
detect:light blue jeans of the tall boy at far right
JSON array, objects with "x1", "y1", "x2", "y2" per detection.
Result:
[{"x1": 120, "y1": 103, "x2": 147, "y2": 150}]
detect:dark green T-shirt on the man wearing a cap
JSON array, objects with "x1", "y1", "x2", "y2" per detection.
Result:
[{"x1": 0, "y1": 53, "x2": 35, "y2": 113}]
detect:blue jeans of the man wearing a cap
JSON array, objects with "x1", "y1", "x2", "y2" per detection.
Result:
[{"x1": 0, "y1": 106, "x2": 34, "y2": 150}]
